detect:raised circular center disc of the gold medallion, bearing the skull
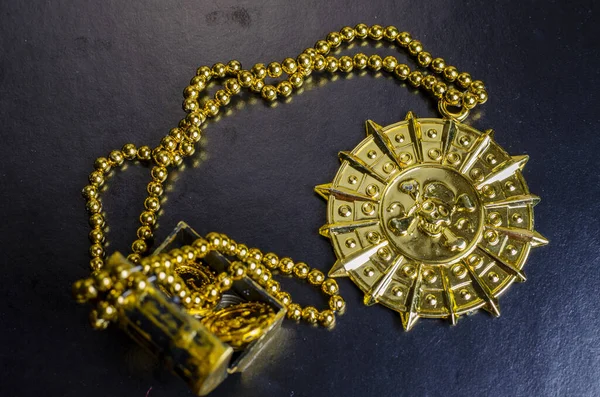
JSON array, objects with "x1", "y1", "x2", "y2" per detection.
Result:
[{"x1": 380, "y1": 165, "x2": 483, "y2": 264}]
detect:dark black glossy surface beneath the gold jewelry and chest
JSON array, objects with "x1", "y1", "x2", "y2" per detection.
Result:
[{"x1": 0, "y1": 0, "x2": 600, "y2": 397}]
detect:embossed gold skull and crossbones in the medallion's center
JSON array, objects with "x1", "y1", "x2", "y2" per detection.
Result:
[{"x1": 388, "y1": 178, "x2": 475, "y2": 251}]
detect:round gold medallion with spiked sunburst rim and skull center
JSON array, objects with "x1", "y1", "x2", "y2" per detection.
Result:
[{"x1": 316, "y1": 112, "x2": 548, "y2": 330}]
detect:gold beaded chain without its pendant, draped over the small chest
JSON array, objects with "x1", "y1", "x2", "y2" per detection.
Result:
[{"x1": 74, "y1": 24, "x2": 487, "y2": 329}]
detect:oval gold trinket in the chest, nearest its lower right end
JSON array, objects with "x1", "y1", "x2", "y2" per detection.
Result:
[{"x1": 202, "y1": 302, "x2": 275, "y2": 350}]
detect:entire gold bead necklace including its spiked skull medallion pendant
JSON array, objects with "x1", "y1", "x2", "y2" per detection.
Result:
[{"x1": 74, "y1": 24, "x2": 547, "y2": 394}]
